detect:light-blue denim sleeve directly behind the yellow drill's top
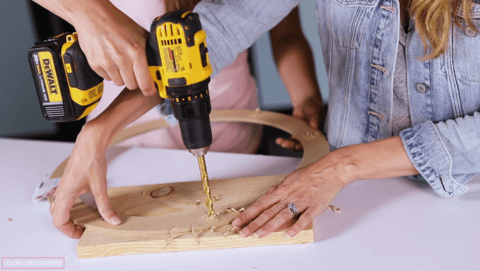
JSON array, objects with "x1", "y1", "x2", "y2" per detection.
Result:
[{"x1": 193, "y1": 0, "x2": 300, "y2": 77}]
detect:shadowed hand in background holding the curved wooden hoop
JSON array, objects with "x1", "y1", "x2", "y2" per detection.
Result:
[{"x1": 275, "y1": 95, "x2": 326, "y2": 151}]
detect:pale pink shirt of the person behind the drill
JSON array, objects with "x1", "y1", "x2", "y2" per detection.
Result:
[{"x1": 87, "y1": 0, "x2": 261, "y2": 153}]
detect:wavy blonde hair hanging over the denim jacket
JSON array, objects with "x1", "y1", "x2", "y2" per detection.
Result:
[{"x1": 409, "y1": 0, "x2": 478, "y2": 61}]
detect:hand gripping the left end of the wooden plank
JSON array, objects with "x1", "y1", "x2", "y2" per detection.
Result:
[{"x1": 50, "y1": 124, "x2": 121, "y2": 239}]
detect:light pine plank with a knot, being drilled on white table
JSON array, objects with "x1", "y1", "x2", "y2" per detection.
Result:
[{"x1": 71, "y1": 175, "x2": 313, "y2": 258}]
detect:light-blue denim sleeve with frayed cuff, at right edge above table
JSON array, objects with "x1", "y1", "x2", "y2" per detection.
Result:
[{"x1": 400, "y1": 112, "x2": 480, "y2": 198}]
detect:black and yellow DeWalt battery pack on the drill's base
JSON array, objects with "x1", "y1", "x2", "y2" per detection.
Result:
[{"x1": 28, "y1": 33, "x2": 103, "y2": 122}]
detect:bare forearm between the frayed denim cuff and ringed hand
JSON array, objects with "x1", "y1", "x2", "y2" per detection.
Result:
[{"x1": 332, "y1": 136, "x2": 418, "y2": 184}]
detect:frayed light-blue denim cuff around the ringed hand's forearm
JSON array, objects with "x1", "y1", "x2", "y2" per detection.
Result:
[{"x1": 400, "y1": 121, "x2": 468, "y2": 198}]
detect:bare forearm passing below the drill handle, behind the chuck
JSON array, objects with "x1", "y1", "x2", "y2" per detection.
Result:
[{"x1": 84, "y1": 89, "x2": 162, "y2": 148}]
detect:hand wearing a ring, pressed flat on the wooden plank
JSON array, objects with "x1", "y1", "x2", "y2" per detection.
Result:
[{"x1": 232, "y1": 151, "x2": 352, "y2": 238}]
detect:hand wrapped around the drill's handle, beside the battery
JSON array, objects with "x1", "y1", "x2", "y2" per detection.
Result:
[{"x1": 72, "y1": 1, "x2": 156, "y2": 96}]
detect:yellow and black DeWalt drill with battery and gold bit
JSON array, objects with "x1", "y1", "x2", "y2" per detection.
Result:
[{"x1": 28, "y1": 11, "x2": 214, "y2": 215}]
